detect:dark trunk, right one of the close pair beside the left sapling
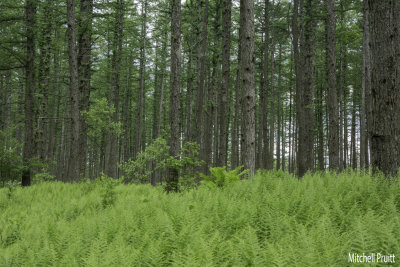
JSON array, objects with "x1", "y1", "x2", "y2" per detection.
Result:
[{"x1": 78, "y1": 0, "x2": 93, "y2": 177}]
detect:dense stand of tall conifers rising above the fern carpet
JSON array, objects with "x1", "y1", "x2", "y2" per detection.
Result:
[{"x1": 0, "y1": 0, "x2": 400, "y2": 188}]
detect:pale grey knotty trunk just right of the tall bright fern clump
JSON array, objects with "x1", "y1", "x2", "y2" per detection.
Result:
[{"x1": 240, "y1": 0, "x2": 256, "y2": 174}]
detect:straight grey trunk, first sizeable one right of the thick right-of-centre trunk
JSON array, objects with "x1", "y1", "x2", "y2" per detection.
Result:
[{"x1": 321, "y1": 0, "x2": 339, "y2": 171}]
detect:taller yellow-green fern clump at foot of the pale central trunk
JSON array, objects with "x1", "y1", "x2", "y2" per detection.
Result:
[{"x1": 200, "y1": 166, "x2": 247, "y2": 187}]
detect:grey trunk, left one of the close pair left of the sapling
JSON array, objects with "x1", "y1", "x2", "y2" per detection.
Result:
[{"x1": 66, "y1": 0, "x2": 80, "y2": 182}]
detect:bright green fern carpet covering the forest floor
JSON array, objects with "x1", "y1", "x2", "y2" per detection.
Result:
[{"x1": 0, "y1": 172, "x2": 400, "y2": 266}]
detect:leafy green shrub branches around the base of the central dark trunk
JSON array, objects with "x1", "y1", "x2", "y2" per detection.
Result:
[{"x1": 120, "y1": 138, "x2": 203, "y2": 185}]
